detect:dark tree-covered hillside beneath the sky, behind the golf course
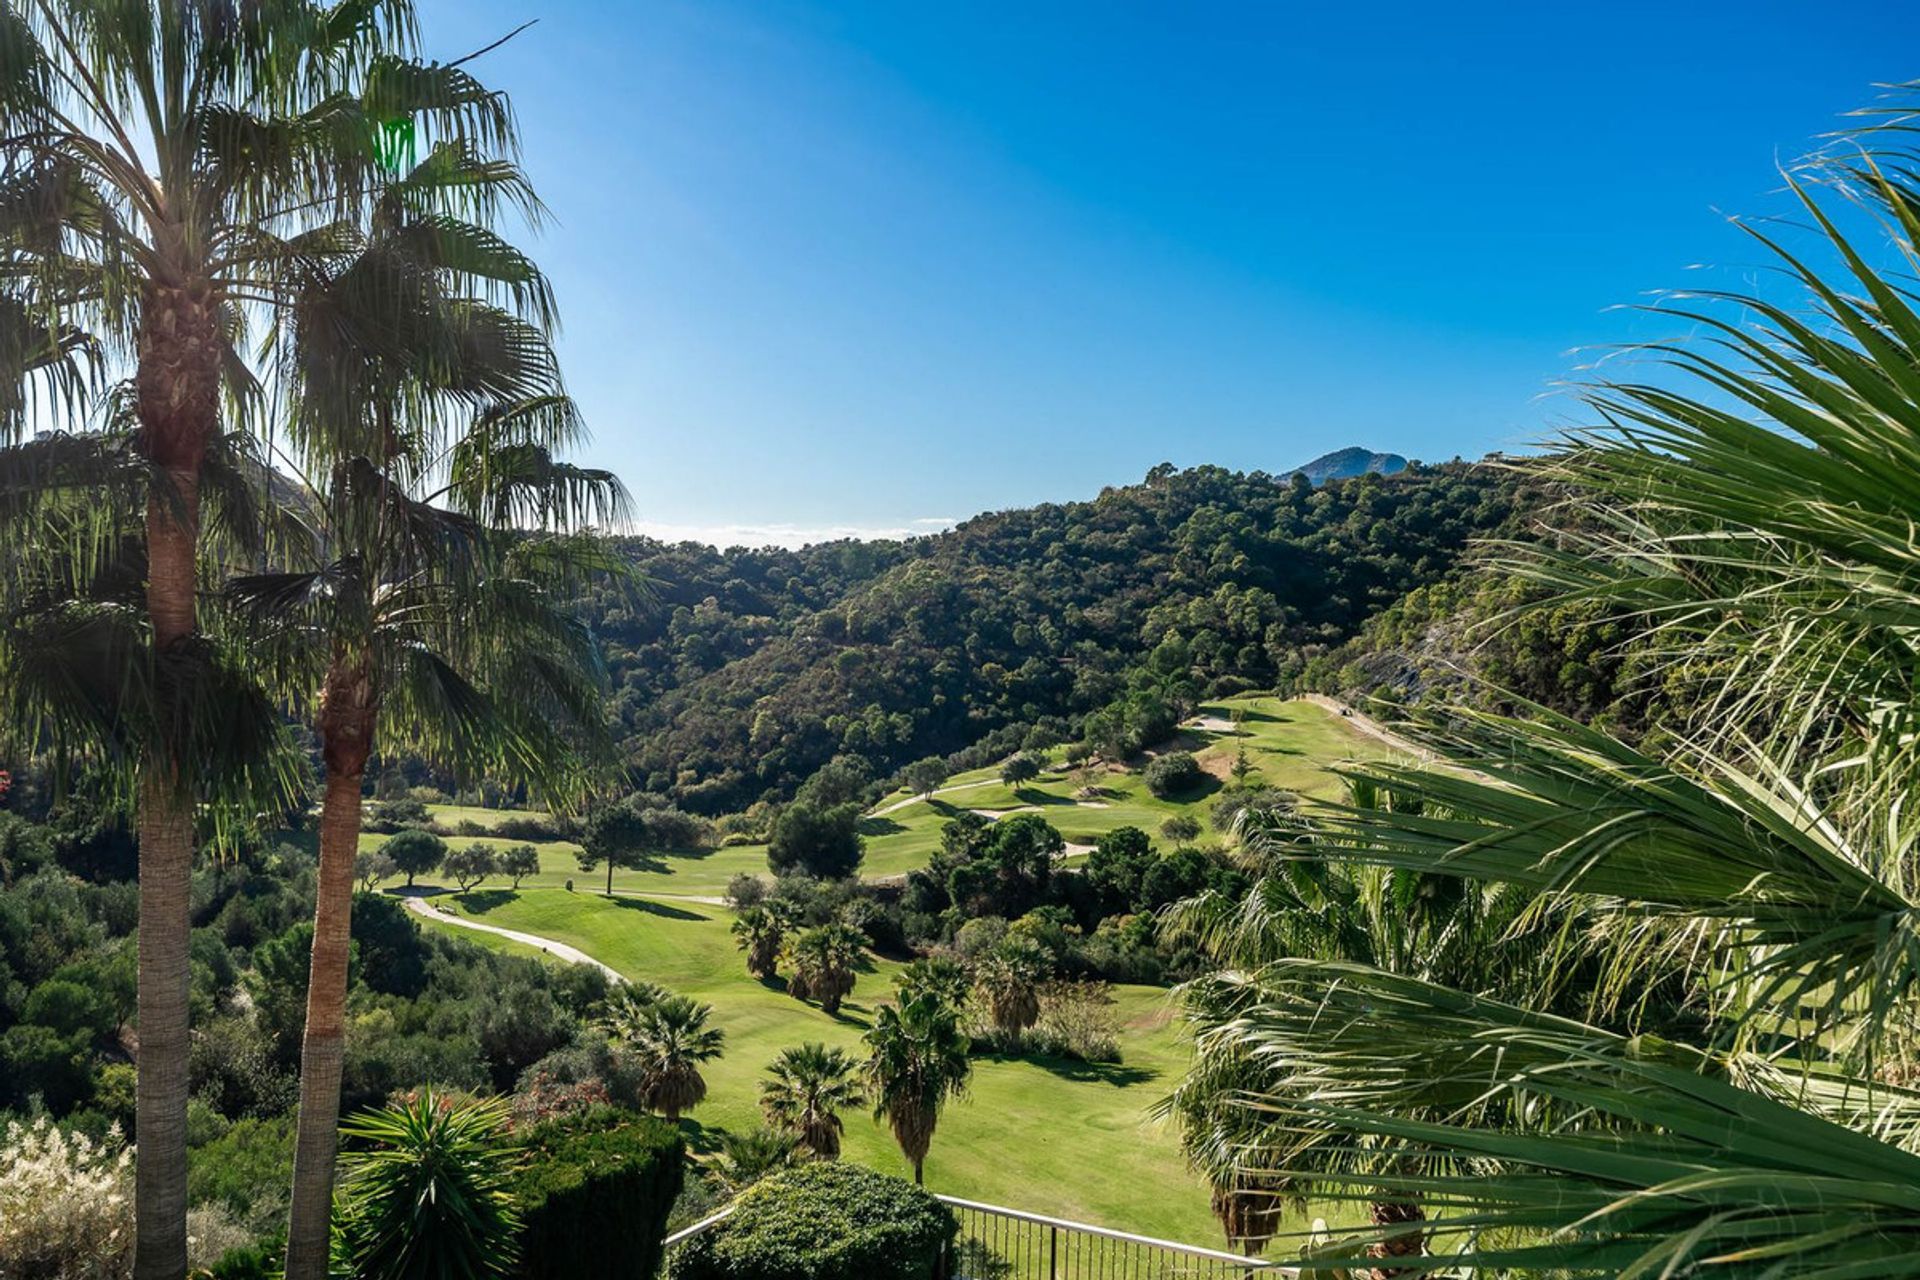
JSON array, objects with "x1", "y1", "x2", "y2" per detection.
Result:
[{"x1": 586, "y1": 462, "x2": 1534, "y2": 814}]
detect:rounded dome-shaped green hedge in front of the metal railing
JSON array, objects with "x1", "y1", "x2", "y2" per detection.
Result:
[{"x1": 668, "y1": 1161, "x2": 960, "y2": 1280}]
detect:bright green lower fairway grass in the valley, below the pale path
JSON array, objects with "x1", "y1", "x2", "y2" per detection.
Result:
[{"x1": 424, "y1": 889, "x2": 1219, "y2": 1245}]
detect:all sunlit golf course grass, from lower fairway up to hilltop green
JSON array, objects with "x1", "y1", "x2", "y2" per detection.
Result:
[{"x1": 389, "y1": 697, "x2": 1380, "y2": 1244}]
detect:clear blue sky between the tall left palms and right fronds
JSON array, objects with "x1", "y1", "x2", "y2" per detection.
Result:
[{"x1": 422, "y1": 0, "x2": 1920, "y2": 541}]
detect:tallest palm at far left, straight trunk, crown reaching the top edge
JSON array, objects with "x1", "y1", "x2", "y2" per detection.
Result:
[{"x1": 0, "y1": 0, "x2": 529, "y2": 1280}]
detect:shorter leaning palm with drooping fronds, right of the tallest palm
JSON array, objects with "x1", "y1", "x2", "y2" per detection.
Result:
[{"x1": 230, "y1": 140, "x2": 624, "y2": 1280}]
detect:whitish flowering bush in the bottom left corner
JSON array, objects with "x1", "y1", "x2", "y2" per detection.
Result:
[{"x1": 0, "y1": 1117, "x2": 132, "y2": 1280}]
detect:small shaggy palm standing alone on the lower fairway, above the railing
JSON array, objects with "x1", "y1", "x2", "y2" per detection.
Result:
[{"x1": 864, "y1": 996, "x2": 973, "y2": 1182}]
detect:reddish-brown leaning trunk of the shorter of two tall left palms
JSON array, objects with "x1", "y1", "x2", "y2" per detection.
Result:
[{"x1": 286, "y1": 660, "x2": 374, "y2": 1280}]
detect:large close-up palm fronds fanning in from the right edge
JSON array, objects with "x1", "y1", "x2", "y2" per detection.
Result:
[{"x1": 1167, "y1": 100, "x2": 1920, "y2": 1278}]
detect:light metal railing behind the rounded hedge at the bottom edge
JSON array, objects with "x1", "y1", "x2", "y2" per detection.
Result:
[{"x1": 666, "y1": 1196, "x2": 1296, "y2": 1280}]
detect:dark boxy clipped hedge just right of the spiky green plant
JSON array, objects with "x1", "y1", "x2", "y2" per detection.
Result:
[{"x1": 513, "y1": 1107, "x2": 687, "y2": 1280}]
